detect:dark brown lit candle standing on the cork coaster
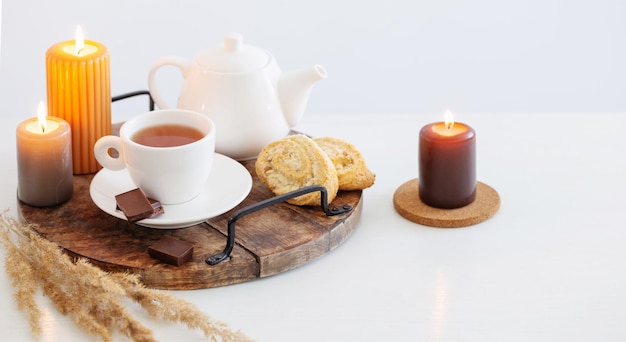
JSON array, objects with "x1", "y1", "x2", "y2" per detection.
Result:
[{"x1": 419, "y1": 111, "x2": 476, "y2": 209}]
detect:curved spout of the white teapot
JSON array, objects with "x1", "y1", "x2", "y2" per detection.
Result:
[{"x1": 278, "y1": 65, "x2": 327, "y2": 127}]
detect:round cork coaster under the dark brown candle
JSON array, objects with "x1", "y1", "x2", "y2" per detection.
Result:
[{"x1": 393, "y1": 178, "x2": 500, "y2": 228}]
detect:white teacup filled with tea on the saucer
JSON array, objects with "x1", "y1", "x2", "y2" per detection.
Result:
[{"x1": 94, "y1": 109, "x2": 215, "y2": 204}]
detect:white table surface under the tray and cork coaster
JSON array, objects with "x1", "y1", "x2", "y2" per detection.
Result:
[{"x1": 0, "y1": 113, "x2": 626, "y2": 341}]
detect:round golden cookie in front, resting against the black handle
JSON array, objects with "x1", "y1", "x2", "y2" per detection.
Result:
[{"x1": 255, "y1": 134, "x2": 339, "y2": 206}]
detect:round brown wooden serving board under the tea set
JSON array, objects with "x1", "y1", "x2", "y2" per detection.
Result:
[{"x1": 19, "y1": 156, "x2": 362, "y2": 290}]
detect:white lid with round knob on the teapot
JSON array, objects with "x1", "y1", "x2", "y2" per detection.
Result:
[{"x1": 196, "y1": 33, "x2": 270, "y2": 73}]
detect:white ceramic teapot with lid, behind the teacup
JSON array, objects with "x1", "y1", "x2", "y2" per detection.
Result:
[{"x1": 148, "y1": 33, "x2": 326, "y2": 160}]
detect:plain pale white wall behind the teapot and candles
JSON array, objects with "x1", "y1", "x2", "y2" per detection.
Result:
[{"x1": 0, "y1": 0, "x2": 626, "y2": 120}]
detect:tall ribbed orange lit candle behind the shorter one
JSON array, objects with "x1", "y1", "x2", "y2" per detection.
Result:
[{"x1": 46, "y1": 27, "x2": 111, "y2": 174}]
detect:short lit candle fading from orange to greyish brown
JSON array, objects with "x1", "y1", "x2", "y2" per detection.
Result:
[{"x1": 16, "y1": 102, "x2": 73, "y2": 207}]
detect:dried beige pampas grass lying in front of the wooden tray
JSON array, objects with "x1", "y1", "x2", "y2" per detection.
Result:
[{"x1": 0, "y1": 211, "x2": 249, "y2": 341}]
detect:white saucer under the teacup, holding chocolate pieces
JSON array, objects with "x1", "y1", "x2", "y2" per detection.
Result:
[{"x1": 89, "y1": 153, "x2": 252, "y2": 229}]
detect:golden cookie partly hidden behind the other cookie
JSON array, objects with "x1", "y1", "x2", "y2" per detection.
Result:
[{"x1": 313, "y1": 137, "x2": 376, "y2": 190}]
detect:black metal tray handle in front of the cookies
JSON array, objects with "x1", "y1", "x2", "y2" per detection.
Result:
[{"x1": 206, "y1": 185, "x2": 352, "y2": 265}]
